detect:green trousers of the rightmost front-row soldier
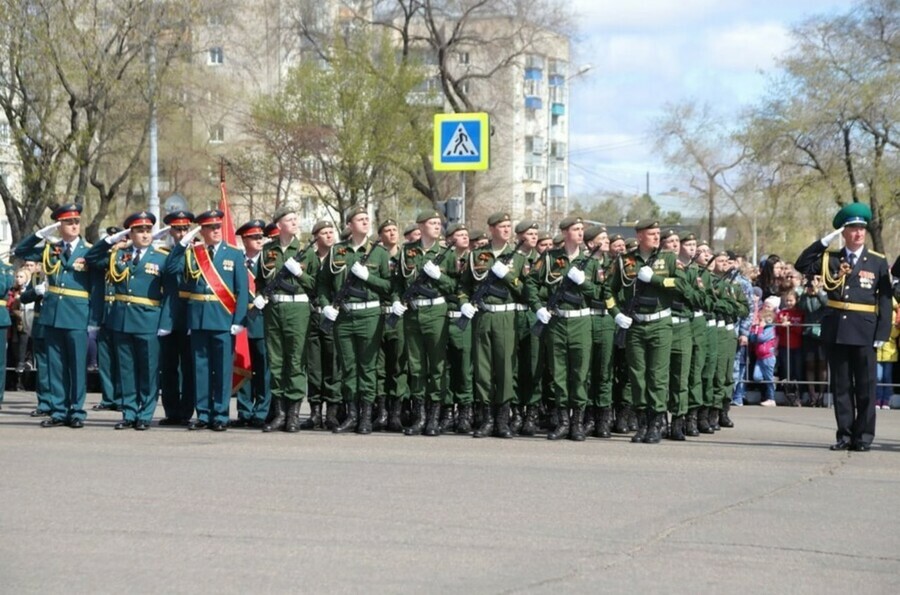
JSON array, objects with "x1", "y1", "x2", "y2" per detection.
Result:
[{"x1": 625, "y1": 316, "x2": 672, "y2": 413}]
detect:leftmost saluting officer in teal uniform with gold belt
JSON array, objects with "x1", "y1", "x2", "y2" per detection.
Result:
[{"x1": 15, "y1": 203, "x2": 102, "y2": 428}]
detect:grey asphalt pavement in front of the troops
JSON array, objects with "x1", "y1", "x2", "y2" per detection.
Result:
[{"x1": 0, "y1": 392, "x2": 900, "y2": 595}]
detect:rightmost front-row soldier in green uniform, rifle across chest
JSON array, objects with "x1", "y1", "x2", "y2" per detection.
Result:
[{"x1": 611, "y1": 221, "x2": 676, "y2": 444}]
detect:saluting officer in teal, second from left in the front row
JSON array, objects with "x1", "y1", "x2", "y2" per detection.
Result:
[{"x1": 86, "y1": 211, "x2": 172, "y2": 430}]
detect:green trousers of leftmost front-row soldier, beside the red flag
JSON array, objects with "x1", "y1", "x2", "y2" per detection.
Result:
[{"x1": 264, "y1": 301, "x2": 311, "y2": 401}]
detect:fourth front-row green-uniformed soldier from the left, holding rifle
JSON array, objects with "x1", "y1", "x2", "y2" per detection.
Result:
[{"x1": 459, "y1": 213, "x2": 525, "y2": 438}]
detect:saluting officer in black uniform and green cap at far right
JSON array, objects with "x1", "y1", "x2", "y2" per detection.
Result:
[{"x1": 795, "y1": 203, "x2": 893, "y2": 452}]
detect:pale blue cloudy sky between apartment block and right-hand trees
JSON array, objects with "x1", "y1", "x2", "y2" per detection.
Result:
[{"x1": 569, "y1": 0, "x2": 854, "y2": 214}]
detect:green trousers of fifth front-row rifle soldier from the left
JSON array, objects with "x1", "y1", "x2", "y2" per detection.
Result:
[{"x1": 546, "y1": 315, "x2": 592, "y2": 409}]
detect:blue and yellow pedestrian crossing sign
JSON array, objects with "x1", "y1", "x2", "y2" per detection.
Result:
[{"x1": 434, "y1": 112, "x2": 490, "y2": 171}]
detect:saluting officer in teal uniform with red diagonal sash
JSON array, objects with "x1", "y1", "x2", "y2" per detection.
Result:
[{"x1": 166, "y1": 210, "x2": 249, "y2": 432}]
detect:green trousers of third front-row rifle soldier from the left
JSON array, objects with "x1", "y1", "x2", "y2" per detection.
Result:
[{"x1": 404, "y1": 304, "x2": 449, "y2": 403}]
